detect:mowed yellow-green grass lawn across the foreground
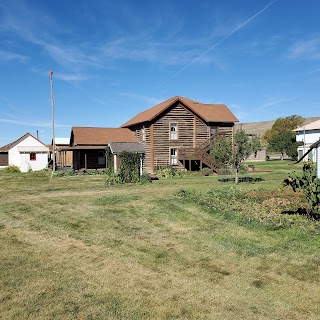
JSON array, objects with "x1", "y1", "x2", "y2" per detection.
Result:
[{"x1": 0, "y1": 161, "x2": 320, "y2": 320}]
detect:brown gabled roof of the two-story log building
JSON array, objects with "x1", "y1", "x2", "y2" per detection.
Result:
[{"x1": 121, "y1": 96, "x2": 239, "y2": 127}]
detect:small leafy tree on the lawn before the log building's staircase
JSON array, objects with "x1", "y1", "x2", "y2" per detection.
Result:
[{"x1": 210, "y1": 129, "x2": 261, "y2": 183}]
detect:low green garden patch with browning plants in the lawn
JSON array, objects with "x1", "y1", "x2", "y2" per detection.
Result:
[{"x1": 178, "y1": 187, "x2": 320, "y2": 232}]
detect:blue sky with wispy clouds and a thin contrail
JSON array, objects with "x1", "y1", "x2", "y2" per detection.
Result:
[{"x1": 0, "y1": 0, "x2": 320, "y2": 146}]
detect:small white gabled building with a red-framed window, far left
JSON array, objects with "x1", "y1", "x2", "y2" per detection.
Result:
[{"x1": 0, "y1": 133, "x2": 49, "y2": 172}]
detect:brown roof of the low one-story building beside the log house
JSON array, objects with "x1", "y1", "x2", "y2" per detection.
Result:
[{"x1": 71, "y1": 127, "x2": 137, "y2": 146}]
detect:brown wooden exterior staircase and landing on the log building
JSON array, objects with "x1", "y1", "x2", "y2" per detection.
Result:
[{"x1": 178, "y1": 133, "x2": 232, "y2": 174}]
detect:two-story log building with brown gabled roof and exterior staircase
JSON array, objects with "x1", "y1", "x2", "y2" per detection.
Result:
[{"x1": 122, "y1": 96, "x2": 238, "y2": 173}]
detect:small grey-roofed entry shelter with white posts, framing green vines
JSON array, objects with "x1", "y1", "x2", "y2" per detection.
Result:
[{"x1": 109, "y1": 142, "x2": 145, "y2": 175}]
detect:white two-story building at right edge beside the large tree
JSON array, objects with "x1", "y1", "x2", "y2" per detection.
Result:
[{"x1": 293, "y1": 120, "x2": 320, "y2": 162}]
